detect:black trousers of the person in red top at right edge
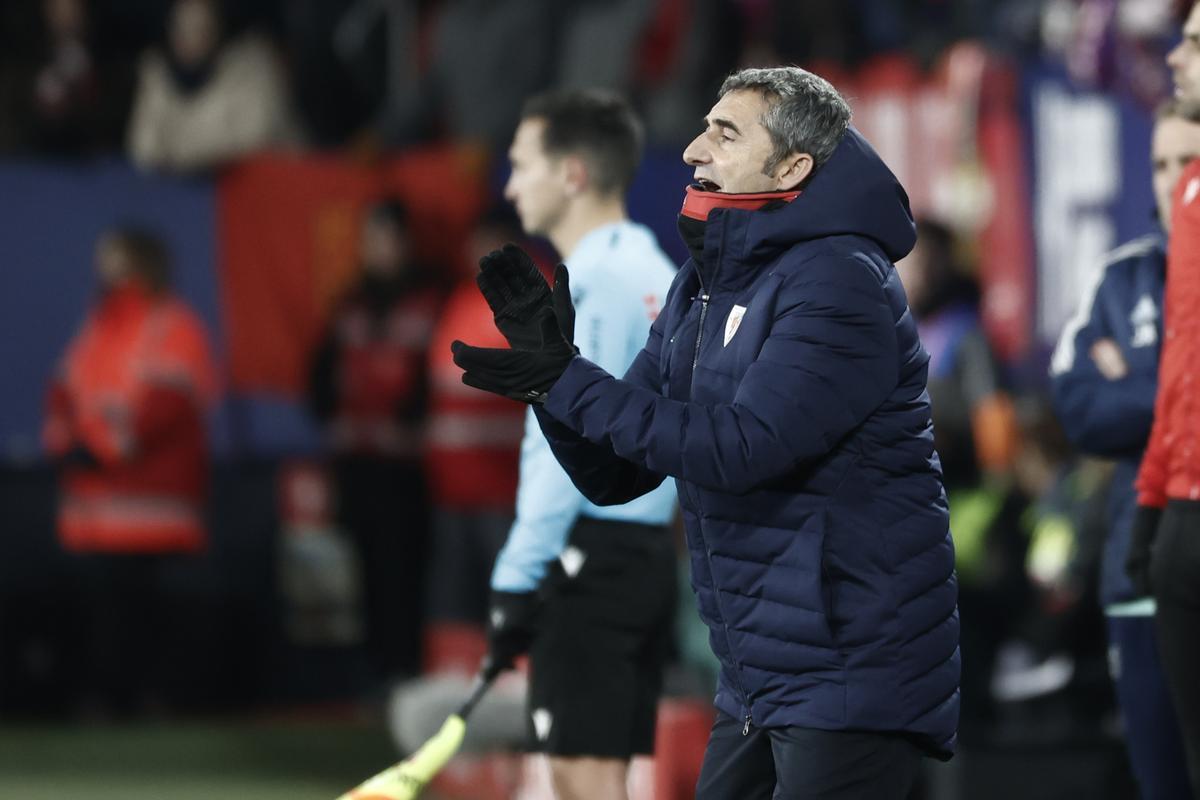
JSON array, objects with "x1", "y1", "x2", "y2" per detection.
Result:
[{"x1": 1150, "y1": 500, "x2": 1200, "y2": 798}]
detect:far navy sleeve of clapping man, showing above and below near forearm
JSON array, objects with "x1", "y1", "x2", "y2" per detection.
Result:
[{"x1": 534, "y1": 287, "x2": 674, "y2": 505}]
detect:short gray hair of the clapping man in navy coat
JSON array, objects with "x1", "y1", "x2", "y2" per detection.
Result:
[{"x1": 719, "y1": 67, "x2": 850, "y2": 174}]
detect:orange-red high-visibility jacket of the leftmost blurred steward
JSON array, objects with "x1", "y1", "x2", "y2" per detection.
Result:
[{"x1": 43, "y1": 285, "x2": 216, "y2": 553}]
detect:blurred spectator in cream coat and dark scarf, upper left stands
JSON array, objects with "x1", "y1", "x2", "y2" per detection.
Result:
[{"x1": 128, "y1": 0, "x2": 299, "y2": 173}]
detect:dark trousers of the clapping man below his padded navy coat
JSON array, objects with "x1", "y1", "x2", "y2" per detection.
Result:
[{"x1": 696, "y1": 712, "x2": 922, "y2": 800}]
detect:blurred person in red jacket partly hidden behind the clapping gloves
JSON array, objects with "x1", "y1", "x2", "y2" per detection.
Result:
[{"x1": 425, "y1": 205, "x2": 526, "y2": 673}]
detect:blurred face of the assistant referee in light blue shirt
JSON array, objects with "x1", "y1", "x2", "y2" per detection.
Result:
[{"x1": 504, "y1": 118, "x2": 570, "y2": 236}]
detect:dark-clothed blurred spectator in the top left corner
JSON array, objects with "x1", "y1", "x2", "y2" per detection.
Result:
[{"x1": 0, "y1": 0, "x2": 132, "y2": 157}]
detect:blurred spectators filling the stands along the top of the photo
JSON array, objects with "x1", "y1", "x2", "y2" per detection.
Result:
[{"x1": 0, "y1": 0, "x2": 1181, "y2": 164}]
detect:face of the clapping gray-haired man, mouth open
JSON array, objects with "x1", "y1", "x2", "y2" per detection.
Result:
[{"x1": 683, "y1": 90, "x2": 794, "y2": 194}]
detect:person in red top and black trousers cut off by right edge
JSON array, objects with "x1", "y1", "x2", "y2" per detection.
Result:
[{"x1": 1126, "y1": 5, "x2": 1200, "y2": 796}]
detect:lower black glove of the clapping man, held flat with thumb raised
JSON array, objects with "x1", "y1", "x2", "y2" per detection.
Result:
[{"x1": 450, "y1": 264, "x2": 578, "y2": 403}]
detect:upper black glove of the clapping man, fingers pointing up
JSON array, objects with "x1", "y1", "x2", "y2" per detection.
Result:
[{"x1": 475, "y1": 243, "x2": 552, "y2": 350}]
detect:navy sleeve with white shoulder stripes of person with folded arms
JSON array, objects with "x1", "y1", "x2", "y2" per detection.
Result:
[{"x1": 1050, "y1": 262, "x2": 1157, "y2": 458}]
